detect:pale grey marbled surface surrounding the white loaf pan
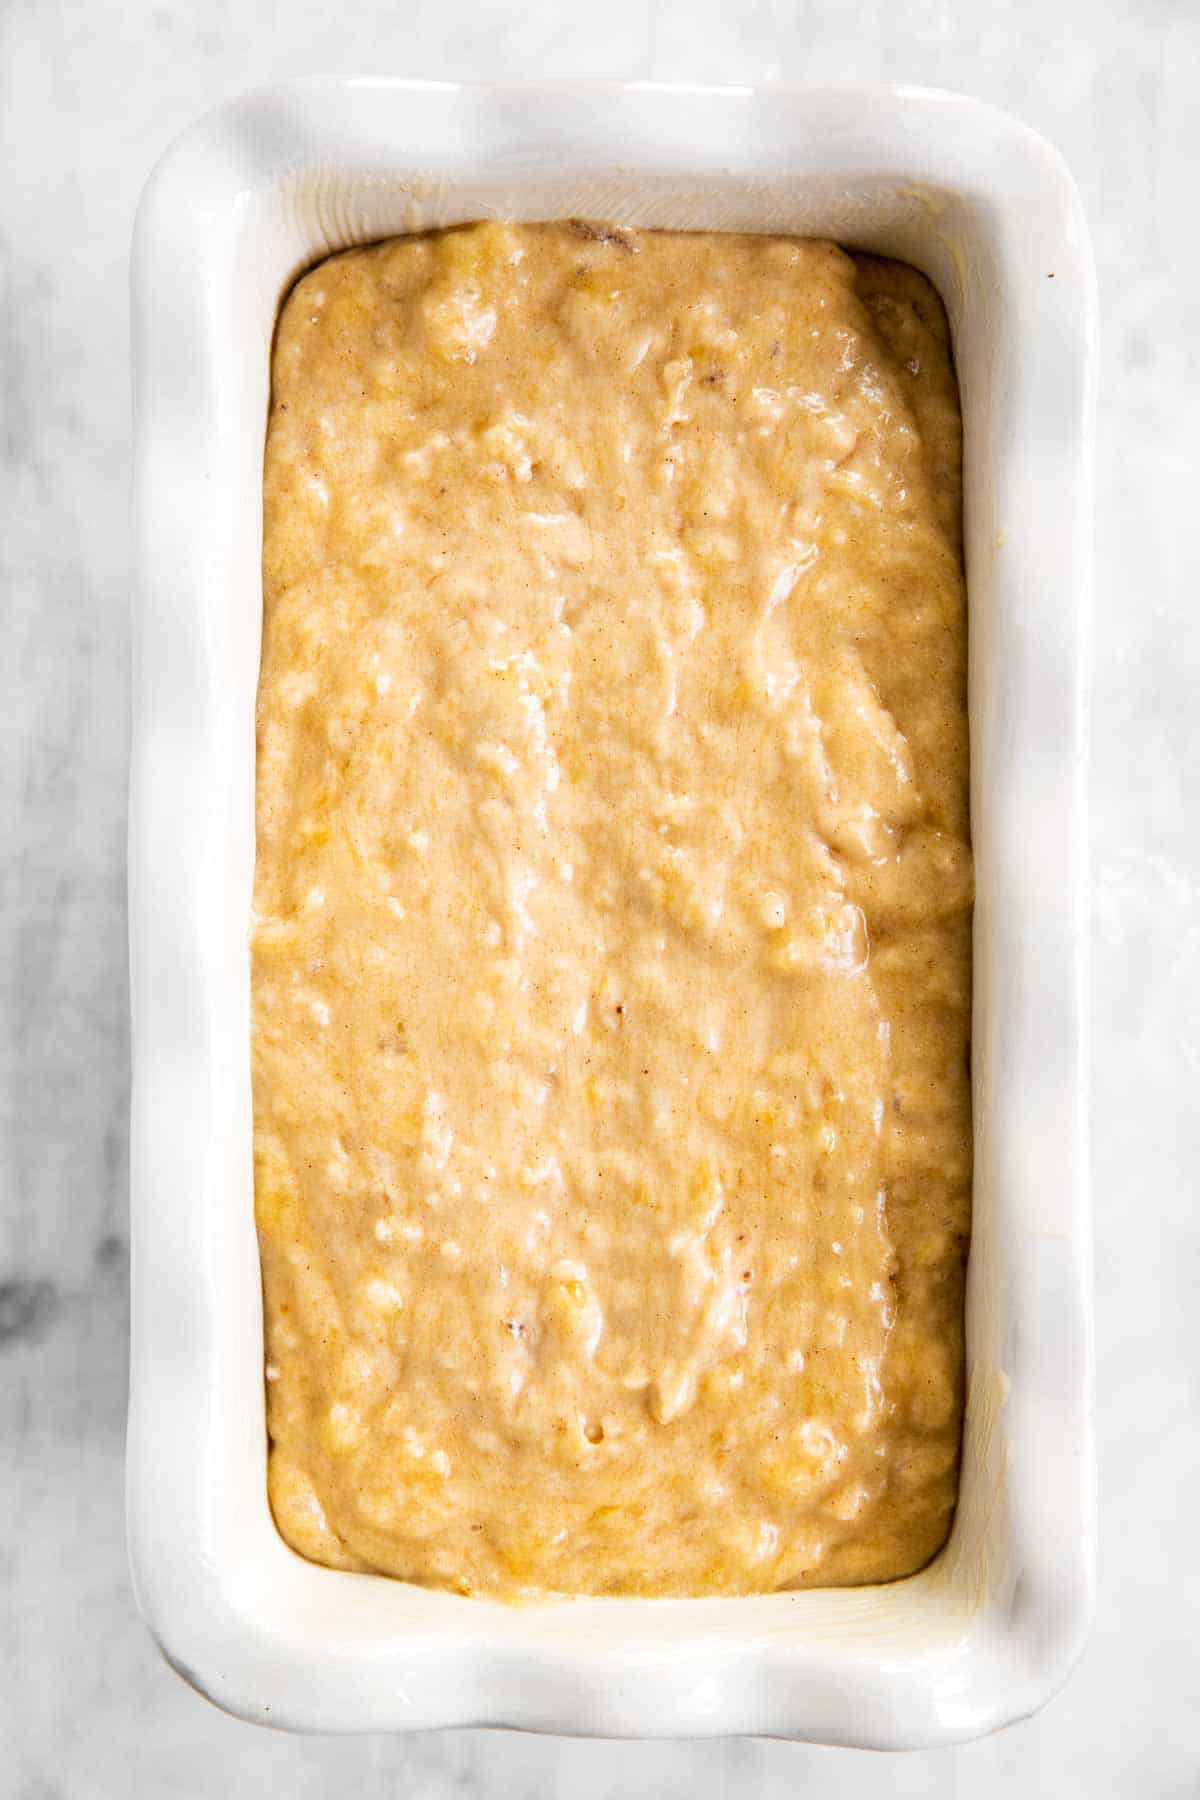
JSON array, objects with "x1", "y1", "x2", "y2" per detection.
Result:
[{"x1": 0, "y1": 0, "x2": 1200, "y2": 1800}]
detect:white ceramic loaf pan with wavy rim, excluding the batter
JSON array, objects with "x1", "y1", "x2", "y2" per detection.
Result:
[{"x1": 128, "y1": 81, "x2": 1096, "y2": 1746}]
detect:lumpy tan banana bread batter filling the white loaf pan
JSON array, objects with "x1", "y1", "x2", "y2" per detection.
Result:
[{"x1": 254, "y1": 225, "x2": 972, "y2": 1598}]
